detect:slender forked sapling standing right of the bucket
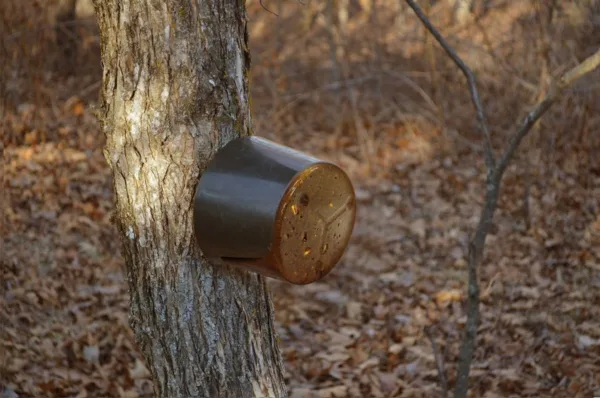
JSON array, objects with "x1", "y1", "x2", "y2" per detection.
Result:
[{"x1": 406, "y1": 0, "x2": 600, "y2": 398}]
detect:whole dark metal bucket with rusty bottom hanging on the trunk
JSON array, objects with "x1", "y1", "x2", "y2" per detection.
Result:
[{"x1": 194, "y1": 137, "x2": 356, "y2": 285}]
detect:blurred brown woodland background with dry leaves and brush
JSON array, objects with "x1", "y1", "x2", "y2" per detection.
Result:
[{"x1": 0, "y1": 0, "x2": 600, "y2": 398}]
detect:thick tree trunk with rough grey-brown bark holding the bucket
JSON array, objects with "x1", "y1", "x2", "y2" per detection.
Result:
[{"x1": 95, "y1": 0, "x2": 286, "y2": 398}]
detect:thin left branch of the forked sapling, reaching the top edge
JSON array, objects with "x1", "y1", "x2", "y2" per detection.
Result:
[{"x1": 406, "y1": 0, "x2": 495, "y2": 172}]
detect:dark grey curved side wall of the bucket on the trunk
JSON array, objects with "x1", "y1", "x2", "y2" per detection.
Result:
[{"x1": 194, "y1": 137, "x2": 319, "y2": 258}]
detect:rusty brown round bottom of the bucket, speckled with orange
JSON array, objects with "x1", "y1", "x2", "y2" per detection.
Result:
[{"x1": 270, "y1": 162, "x2": 356, "y2": 284}]
